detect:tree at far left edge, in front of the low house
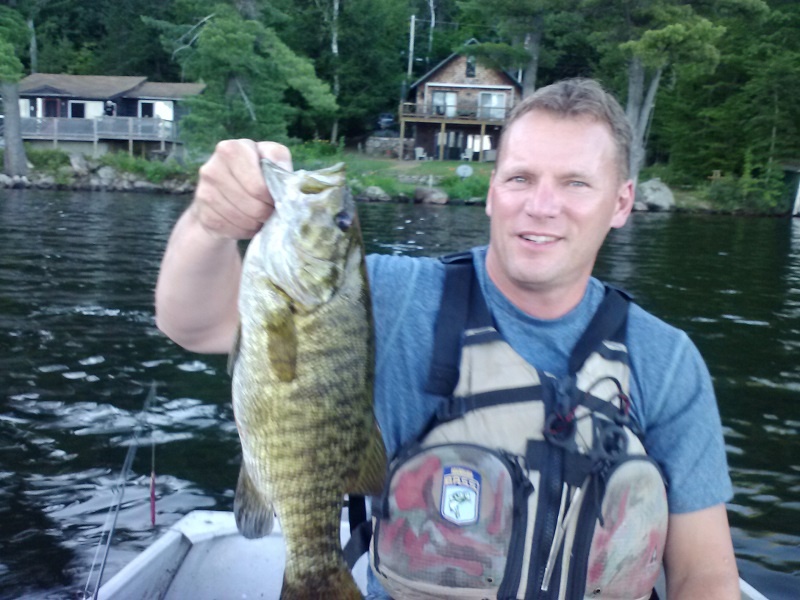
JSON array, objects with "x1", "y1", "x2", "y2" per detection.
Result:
[{"x1": 0, "y1": 6, "x2": 28, "y2": 176}]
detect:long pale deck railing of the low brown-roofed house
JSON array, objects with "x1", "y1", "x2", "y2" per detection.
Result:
[{"x1": 21, "y1": 117, "x2": 177, "y2": 143}]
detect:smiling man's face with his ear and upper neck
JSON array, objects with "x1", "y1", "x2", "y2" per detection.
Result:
[{"x1": 486, "y1": 111, "x2": 633, "y2": 312}]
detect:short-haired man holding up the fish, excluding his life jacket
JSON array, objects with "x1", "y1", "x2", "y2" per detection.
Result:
[{"x1": 156, "y1": 80, "x2": 739, "y2": 599}]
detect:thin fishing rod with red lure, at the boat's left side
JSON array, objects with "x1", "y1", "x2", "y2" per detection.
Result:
[{"x1": 83, "y1": 382, "x2": 156, "y2": 600}]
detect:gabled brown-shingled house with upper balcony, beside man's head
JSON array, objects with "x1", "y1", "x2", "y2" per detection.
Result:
[{"x1": 400, "y1": 39, "x2": 522, "y2": 161}]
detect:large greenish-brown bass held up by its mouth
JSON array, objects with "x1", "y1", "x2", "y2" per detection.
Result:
[{"x1": 229, "y1": 159, "x2": 386, "y2": 600}]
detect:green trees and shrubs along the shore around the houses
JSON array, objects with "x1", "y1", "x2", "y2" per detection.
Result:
[{"x1": 0, "y1": 0, "x2": 800, "y2": 210}]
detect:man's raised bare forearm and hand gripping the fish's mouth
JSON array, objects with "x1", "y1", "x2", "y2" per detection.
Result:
[{"x1": 155, "y1": 140, "x2": 291, "y2": 353}]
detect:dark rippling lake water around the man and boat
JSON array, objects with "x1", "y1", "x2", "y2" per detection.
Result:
[{"x1": 0, "y1": 190, "x2": 800, "y2": 598}]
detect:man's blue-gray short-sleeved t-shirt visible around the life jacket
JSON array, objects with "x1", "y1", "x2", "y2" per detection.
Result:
[{"x1": 367, "y1": 247, "x2": 732, "y2": 597}]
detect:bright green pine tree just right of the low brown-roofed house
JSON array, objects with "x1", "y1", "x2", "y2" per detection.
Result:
[{"x1": 150, "y1": 4, "x2": 336, "y2": 148}]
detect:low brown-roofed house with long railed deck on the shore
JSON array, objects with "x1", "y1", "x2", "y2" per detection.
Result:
[{"x1": 19, "y1": 73, "x2": 205, "y2": 156}]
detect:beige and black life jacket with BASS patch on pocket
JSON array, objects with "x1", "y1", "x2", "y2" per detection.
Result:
[{"x1": 370, "y1": 253, "x2": 668, "y2": 600}]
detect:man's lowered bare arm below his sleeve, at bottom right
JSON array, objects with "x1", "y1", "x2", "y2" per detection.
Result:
[{"x1": 664, "y1": 504, "x2": 740, "y2": 600}]
